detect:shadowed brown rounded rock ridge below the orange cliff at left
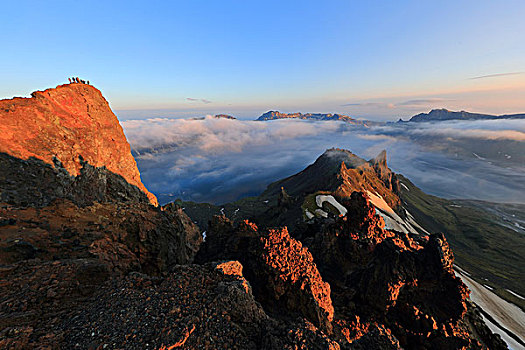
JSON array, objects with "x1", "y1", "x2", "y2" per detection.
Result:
[{"x1": 0, "y1": 200, "x2": 202, "y2": 348}]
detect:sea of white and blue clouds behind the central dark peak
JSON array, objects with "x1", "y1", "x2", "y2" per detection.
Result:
[{"x1": 121, "y1": 116, "x2": 525, "y2": 203}]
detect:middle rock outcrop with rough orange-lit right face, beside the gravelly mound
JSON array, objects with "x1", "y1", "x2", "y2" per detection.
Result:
[{"x1": 196, "y1": 217, "x2": 333, "y2": 331}]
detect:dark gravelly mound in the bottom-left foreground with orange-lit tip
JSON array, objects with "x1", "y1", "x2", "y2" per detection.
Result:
[{"x1": 0, "y1": 261, "x2": 340, "y2": 350}]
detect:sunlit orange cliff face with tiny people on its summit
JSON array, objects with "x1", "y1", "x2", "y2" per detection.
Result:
[{"x1": 0, "y1": 83, "x2": 157, "y2": 205}]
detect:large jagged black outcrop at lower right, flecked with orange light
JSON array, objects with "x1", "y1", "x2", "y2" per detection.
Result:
[{"x1": 296, "y1": 192, "x2": 505, "y2": 349}]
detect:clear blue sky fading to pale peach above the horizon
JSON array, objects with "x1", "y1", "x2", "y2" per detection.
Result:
[{"x1": 0, "y1": 0, "x2": 525, "y2": 119}]
